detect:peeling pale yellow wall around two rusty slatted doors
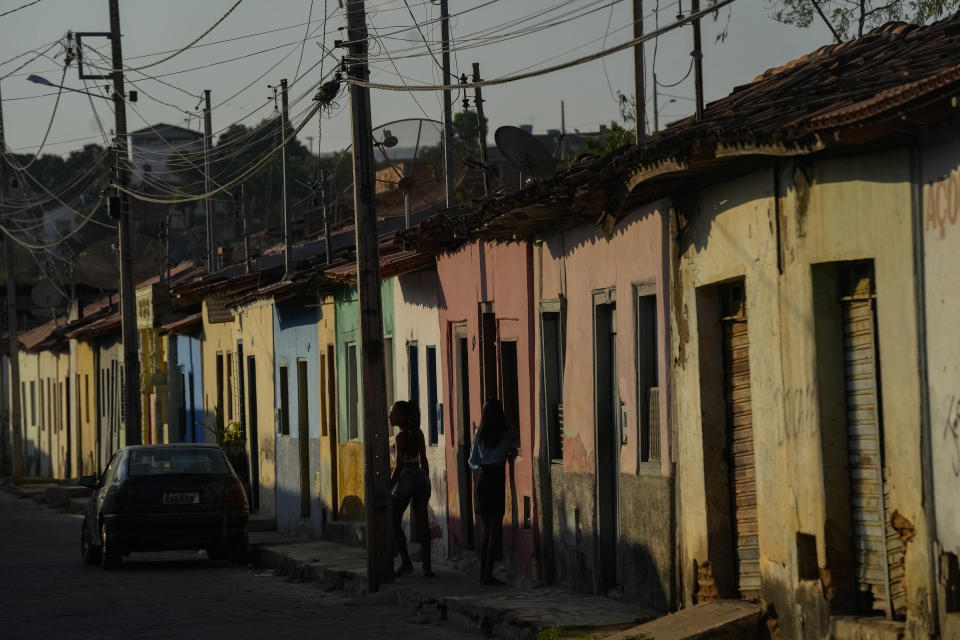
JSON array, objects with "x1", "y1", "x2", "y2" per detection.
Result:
[{"x1": 672, "y1": 152, "x2": 931, "y2": 639}]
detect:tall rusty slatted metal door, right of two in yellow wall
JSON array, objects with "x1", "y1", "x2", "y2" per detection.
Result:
[{"x1": 841, "y1": 263, "x2": 906, "y2": 617}]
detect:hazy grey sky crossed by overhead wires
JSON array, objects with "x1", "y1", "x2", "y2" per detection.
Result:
[{"x1": 0, "y1": 0, "x2": 830, "y2": 160}]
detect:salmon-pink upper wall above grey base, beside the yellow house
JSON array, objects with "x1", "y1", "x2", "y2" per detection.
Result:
[{"x1": 533, "y1": 203, "x2": 670, "y2": 474}]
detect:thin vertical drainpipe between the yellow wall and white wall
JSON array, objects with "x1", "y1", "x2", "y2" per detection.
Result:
[{"x1": 910, "y1": 147, "x2": 941, "y2": 637}]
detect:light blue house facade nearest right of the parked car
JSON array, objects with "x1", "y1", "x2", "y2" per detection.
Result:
[{"x1": 273, "y1": 296, "x2": 322, "y2": 535}]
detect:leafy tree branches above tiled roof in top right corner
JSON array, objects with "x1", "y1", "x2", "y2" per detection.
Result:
[{"x1": 768, "y1": 0, "x2": 960, "y2": 42}]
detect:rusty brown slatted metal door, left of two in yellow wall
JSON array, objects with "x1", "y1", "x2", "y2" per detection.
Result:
[{"x1": 720, "y1": 284, "x2": 760, "y2": 600}]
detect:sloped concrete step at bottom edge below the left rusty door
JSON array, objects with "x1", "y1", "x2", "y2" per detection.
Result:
[{"x1": 605, "y1": 600, "x2": 761, "y2": 640}]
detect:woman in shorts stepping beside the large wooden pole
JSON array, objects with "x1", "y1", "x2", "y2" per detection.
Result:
[{"x1": 389, "y1": 400, "x2": 433, "y2": 578}]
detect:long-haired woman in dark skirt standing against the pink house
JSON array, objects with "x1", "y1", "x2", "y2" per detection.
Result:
[{"x1": 469, "y1": 398, "x2": 516, "y2": 585}]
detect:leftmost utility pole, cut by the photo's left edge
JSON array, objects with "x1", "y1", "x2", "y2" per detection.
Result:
[{"x1": 0, "y1": 80, "x2": 23, "y2": 485}]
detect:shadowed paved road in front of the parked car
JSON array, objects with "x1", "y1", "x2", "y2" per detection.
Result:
[{"x1": 0, "y1": 490, "x2": 480, "y2": 640}]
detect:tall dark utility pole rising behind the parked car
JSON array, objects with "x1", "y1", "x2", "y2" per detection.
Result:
[{"x1": 110, "y1": 0, "x2": 142, "y2": 445}]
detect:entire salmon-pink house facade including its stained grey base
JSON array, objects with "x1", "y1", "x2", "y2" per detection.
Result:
[{"x1": 534, "y1": 203, "x2": 673, "y2": 610}]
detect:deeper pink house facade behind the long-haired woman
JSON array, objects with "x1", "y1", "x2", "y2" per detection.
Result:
[{"x1": 437, "y1": 242, "x2": 537, "y2": 578}]
